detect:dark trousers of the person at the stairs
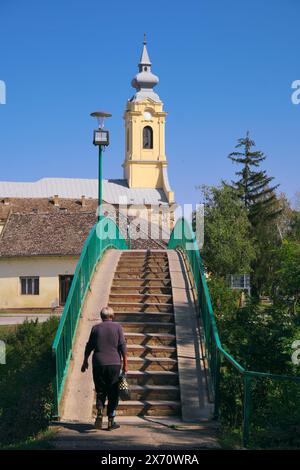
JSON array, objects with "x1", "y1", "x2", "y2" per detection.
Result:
[{"x1": 93, "y1": 365, "x2": 121, "y2": 416}]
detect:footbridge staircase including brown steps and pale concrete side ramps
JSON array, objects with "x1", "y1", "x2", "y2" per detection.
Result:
[{"x1": 60, "y1": 249, "x2": 212, "y2": 428}]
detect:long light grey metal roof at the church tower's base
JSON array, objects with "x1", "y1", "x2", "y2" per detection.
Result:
[{"x1": 0, "y1": 178, "x2": 168, "y2": 205}]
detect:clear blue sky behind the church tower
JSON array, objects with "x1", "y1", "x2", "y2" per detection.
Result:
[{"x1": 0, "y1": 0, "x2": 300, "y2": 207}]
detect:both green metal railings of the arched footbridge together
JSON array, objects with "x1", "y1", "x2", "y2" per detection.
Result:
[{"x1": 53, "y1": 218, "x2": 300, "y2": 446}]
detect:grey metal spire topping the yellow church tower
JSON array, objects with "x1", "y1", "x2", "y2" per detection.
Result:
[{"x1": 131, "y1": 34, "x2": 161, "y2": 103}]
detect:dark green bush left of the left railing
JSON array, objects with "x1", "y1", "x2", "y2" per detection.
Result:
[{"x1": 0, "y1": 318, "x2": 58, "y2": 445}]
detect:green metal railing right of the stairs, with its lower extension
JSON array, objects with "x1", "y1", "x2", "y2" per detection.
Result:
[{"x1": 168, "y1": 218, "x2": 300, "y2": 446}]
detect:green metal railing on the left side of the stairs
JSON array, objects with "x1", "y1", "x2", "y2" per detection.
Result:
[{"x1": 52, "y1": 217, "x2": 127, "y2": 416}]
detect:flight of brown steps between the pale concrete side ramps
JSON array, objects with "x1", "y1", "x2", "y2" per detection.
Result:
[{"x1": 109, "y1": 250, "x2": 181, "y2": 416}]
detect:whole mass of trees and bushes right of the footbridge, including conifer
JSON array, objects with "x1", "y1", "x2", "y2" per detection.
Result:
[{"x1": 195, "y1": 133, "x2": 300, "y2": 448}]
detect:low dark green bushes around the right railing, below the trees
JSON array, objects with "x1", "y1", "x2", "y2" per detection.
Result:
[{"x1": 209, "y1": 278, "x2": 300, "y2": 447}]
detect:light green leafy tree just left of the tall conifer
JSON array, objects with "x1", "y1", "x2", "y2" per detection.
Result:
[{"x1": 198, "y1": 185, "x2": 254, "y2": 277}]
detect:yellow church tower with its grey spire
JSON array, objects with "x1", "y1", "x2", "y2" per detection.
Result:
[{"x1": 123, "y1": 36, "x2": 174, "y2": 204}]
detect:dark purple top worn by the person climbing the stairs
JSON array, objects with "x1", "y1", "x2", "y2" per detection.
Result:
[{"x1": 85, "y1": 320, "x2": 126, "y2": 366}]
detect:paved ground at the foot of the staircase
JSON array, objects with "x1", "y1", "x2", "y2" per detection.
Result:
[{"x1": 51, "y1": 417, "x2": 220, "y2": 451}]
